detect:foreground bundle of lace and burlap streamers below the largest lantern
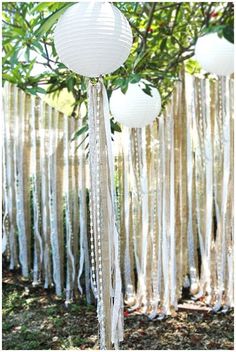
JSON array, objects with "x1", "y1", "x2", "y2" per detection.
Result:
[{"x1": 88, "y1": 80, "x2": 123, "y2": 348}]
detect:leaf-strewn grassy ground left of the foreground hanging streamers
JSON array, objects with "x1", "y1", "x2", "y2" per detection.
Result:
[{"x1": 2, "y1": 275, "x2": 98, "y2": 350}]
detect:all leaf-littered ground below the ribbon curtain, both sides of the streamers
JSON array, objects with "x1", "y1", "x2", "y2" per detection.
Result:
[{"x1": 2, "y1": 272, "x2": 234, "y2": 350}]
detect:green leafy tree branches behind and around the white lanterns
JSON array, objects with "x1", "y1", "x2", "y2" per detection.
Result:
[{"x1": 2, "y1": 2, "x2": 233, "y2": 116}]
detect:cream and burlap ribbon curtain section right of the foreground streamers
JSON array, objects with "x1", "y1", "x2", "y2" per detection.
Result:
[{"x1": 116, "y1": 74, "x2": 233, "y2": 319}]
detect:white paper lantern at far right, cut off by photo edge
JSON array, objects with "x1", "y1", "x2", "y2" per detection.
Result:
[{"x1": 195, "y1": 33, "x2": 234, "y2": 76}]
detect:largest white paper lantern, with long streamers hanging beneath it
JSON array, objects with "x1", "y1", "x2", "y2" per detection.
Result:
[{"x1": 54, "y1": 1, "x2": 133, "y2": 77}]
